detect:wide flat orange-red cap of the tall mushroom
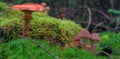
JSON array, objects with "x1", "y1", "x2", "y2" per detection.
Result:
[{"x1": 12, "y1": 3, "x2": 44, "y2": 11}]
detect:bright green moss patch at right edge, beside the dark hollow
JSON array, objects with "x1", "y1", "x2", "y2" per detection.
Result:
[{"x1": 100, "y1": 32, "x2": 120, "y2": 55}]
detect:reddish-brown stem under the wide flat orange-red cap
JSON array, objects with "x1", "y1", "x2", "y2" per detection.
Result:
[{"x1": 22, "y1": 10, "x2": 32, "y2": 37}]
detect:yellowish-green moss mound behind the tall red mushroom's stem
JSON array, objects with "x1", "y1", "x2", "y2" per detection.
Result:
[{"x1": 0, "y1": 10, "x2": 82, "y2": 44}]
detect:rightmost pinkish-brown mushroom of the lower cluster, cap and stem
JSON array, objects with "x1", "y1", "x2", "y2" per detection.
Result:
[{"x1": 91, "y1": 33, "x2": 101, "y2": 54}]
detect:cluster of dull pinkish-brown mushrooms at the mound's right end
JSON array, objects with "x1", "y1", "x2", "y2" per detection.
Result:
[{"x1": 71, "y1": 29, "x2": 101, "y2": 54}]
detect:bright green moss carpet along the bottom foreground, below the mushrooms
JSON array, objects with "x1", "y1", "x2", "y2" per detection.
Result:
[{"x1": 0, "y1": 39, "x2": 103, "y2": 59}]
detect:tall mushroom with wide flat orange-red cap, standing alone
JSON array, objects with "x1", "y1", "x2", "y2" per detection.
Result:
[{"x1": 12, "y1": 3, "x2": 44, "y2": 37}]
